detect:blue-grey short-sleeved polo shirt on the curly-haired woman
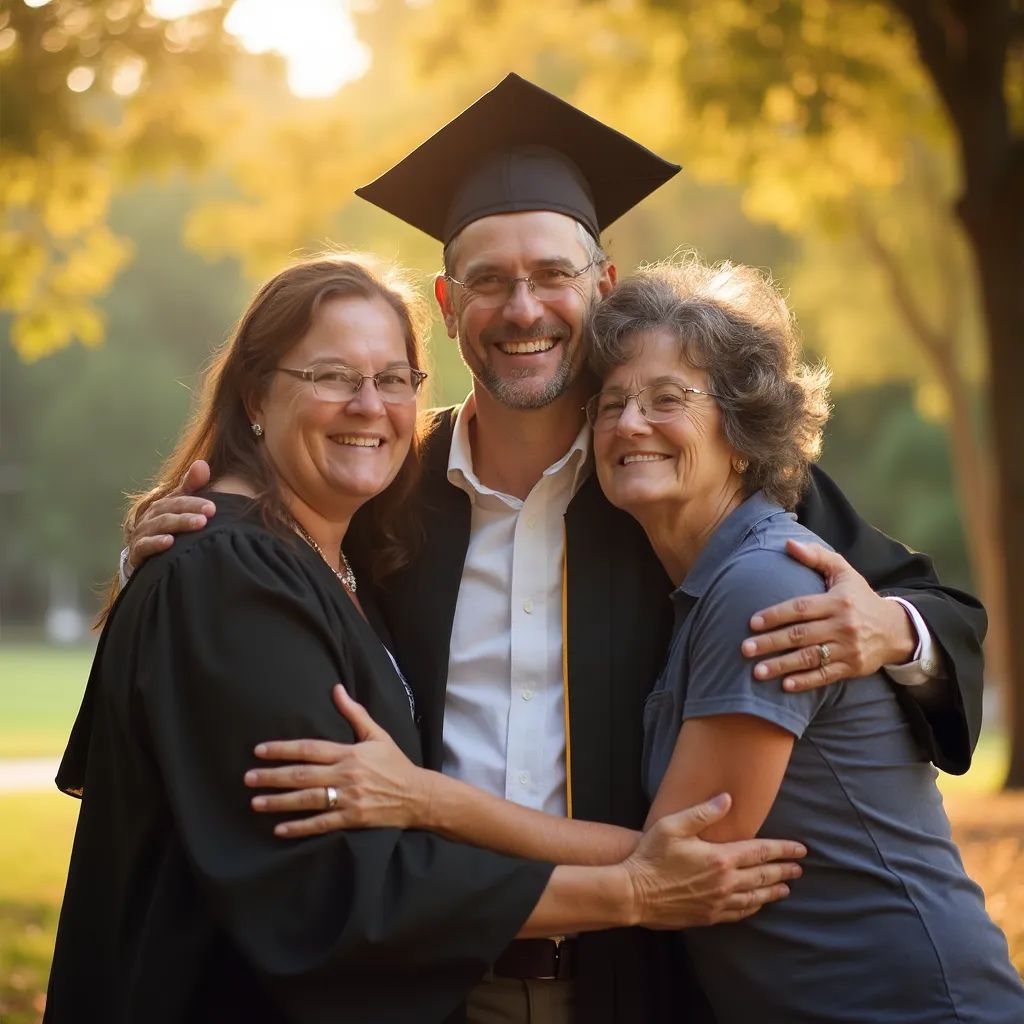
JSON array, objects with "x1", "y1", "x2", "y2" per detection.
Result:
[{"x1": 643, "y1": 493, "x2": 1024, "y2": 1024}]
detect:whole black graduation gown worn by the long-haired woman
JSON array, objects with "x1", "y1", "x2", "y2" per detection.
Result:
[{"x1": 46, "y1": 495, "x2": 551, "y2": 1024}]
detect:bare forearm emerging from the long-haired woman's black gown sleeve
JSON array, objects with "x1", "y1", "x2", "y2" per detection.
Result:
[{"x1": 519, "y1": 865, "x2": 639, "y2": 939}]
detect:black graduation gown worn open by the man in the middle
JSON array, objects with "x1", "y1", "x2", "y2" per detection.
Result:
[{"x1": 353, "y1": 409, "x2": 986, "y2": 1024}]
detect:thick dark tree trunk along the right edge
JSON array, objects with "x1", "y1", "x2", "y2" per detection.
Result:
[{"x1": 891, "y1": 0, "x2": 1024, "y2": 788}]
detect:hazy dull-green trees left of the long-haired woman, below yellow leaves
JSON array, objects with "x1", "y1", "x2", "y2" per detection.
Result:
[{"x1": 0, "y1": 180, "x2": 241, "y2": 622}]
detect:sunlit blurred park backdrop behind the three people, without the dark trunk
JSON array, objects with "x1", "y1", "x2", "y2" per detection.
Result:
[{"x1": 0, "y1": 0, "x2": 1024, "y2": 1024}]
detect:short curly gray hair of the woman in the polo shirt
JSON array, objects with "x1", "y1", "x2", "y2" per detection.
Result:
[{"x1": 590, "y1": 253, "x2": 831, "y2": 510}]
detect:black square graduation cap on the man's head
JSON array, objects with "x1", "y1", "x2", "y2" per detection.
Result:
[{"x1": 355, "y1": 75, "x2": 680, "y2": 245}]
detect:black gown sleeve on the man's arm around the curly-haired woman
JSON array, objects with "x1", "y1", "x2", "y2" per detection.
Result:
[{"x1": 797, "y1": 466, "x2": 988, "y2": 775}]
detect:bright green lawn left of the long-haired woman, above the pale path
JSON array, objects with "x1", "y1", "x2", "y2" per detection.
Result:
[{"x1": 0, "y1": 643, "x2": 93, "y2": 757}]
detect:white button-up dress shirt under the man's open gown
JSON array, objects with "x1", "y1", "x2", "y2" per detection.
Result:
[{"x1": 441, "y1": 398, "x2": 590, "y2": 816}]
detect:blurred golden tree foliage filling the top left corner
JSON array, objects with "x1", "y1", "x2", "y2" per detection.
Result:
[{"x1": 0, "y1": 0, "x2": 231, "y2": 359}]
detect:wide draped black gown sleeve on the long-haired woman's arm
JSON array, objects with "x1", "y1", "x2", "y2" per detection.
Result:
[{"x1": 98, "y1": 530, "x2": 551, "y2": 1022}]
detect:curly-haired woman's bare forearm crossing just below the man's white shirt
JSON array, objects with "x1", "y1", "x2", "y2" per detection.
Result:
[{"x1": 423, "y1": 772, "x2": 640, "y2": 864}]
